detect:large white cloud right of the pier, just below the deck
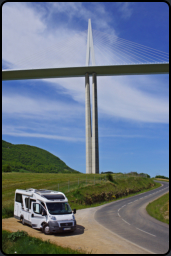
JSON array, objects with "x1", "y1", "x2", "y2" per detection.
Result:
[{"x1": 98, "y1": 77, "x2": 169, "y2": 123}]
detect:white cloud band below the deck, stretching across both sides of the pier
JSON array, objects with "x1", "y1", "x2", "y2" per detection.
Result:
[{"x1": 2, "y1": 76, "x2": 169, "y2": 123}]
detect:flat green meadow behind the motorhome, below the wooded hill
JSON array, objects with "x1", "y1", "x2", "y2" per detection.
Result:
[{"x1": 2, "y1": 172, "x2": 97, "y2": 209}]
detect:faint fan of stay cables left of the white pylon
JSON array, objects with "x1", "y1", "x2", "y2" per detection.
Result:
[{"x1": 3, "y1": 30, "x2": 87, "y2": 69}]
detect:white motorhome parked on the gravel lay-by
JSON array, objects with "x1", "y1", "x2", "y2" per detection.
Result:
[{"x1": 14, "y1": 188, "x2": 76, "y2": 235}]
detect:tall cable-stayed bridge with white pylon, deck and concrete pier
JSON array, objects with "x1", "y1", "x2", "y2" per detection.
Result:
[{"x1": 2, "y1": 19, "x2": 169, "y2": 173}]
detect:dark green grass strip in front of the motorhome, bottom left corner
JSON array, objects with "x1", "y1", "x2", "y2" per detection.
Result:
[{"x1": 2, "y1": 230, "x2": 86, "y2": 254}]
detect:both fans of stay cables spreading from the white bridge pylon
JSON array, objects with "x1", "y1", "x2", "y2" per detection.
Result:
[{"x1": 2, "y1": 29, "x2": 169, "y2": 69}]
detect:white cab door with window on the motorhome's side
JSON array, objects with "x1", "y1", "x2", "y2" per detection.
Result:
[{"x1": 30, "y1": 202, "x2": 47, "y2": 228}]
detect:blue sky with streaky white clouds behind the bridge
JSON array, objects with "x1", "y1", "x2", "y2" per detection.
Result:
[{"x1": 2, "y1": 2, "x2": 169, "y2": 177}]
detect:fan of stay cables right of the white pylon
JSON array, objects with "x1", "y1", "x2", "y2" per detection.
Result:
[{"x1": 92, "y1": 29, "x2": 169, "y2": 65}]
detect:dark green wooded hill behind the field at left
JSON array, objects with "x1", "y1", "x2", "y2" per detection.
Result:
[{"x1": 2, "y1": 140, "x2": 80, "y2": 173}]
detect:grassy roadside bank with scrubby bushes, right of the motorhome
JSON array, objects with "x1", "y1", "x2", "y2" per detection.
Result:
[{"x1": 65, "y1": 177, "x2": 161, "y2": 209}]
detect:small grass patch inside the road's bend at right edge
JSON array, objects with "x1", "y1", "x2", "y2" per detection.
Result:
[{"x1": 146, "y1": 193, "x2": 169, "y2": 224}]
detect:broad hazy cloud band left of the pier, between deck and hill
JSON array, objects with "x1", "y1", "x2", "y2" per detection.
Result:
[{"x1": 2, "y1": 94, "x2": 84, "y2": 120}]
